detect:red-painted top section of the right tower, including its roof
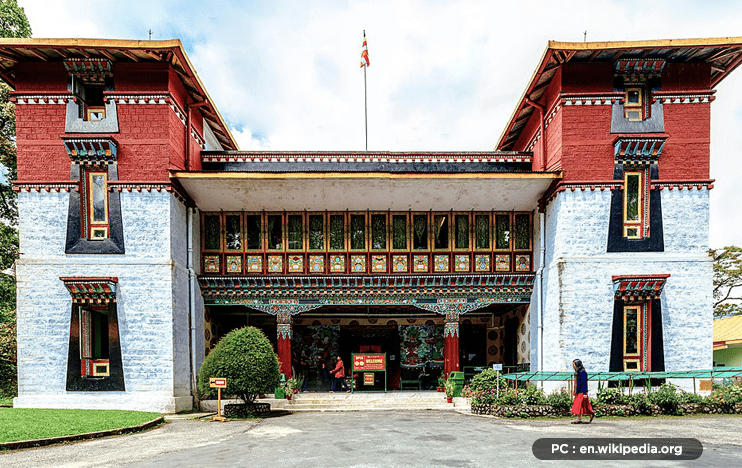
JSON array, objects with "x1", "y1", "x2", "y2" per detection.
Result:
[{"x1": 497, "y1": 38, "x2": 740, "y2": 183}]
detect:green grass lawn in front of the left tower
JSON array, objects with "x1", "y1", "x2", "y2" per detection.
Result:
[{"x1": 0, "y1": 408, "x2": 160, "y2": 443}]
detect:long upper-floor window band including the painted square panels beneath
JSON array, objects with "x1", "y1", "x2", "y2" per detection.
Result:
[{"x1": 201, "y1": 211, "x2": 533, "y2": 274}]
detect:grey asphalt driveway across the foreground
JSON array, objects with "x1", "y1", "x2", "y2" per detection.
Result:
[{"x1": 0, "y1": 411, "x2": 742, "y2": 468}]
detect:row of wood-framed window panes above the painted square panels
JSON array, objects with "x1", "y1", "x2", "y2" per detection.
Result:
[{"x1": 201, "y1": 212, "x2": 532, "y2": 252}]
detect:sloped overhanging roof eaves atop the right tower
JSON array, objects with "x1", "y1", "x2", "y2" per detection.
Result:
[{"x1": 495, "y1": 37, "x2": 742, "y2": 151}]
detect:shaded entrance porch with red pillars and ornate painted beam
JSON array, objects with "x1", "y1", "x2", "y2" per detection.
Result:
[{"x1": 201, "y1": 274, "x2": 533, "y2": 391}]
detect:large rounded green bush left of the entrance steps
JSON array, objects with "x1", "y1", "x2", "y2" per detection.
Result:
[{"x1": 198, "y1": 327, "x2": 280, "y2": 404}]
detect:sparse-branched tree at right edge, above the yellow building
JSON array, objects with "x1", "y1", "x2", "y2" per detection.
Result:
[{"x1": 711, "y1": 246, "x2": 742, "y2": 317}]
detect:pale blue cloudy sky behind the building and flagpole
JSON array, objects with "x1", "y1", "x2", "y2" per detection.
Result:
[{"x1": 19, "y1": 0, "x2": 742, "y2": 247}]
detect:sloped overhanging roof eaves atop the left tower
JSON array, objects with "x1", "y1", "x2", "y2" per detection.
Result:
[{"x1": 0, "y1": 38, "x2": 237, "y2": 150}]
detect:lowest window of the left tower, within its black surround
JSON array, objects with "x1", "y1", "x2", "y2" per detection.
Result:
[{"x1": 79, "y1": 309, "x2": 109, "y2": 377}]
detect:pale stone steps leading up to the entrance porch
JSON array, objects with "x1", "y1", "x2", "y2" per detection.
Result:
[{"x1": 201, "y1": 391, "x2": 470, "y2": 413}]
